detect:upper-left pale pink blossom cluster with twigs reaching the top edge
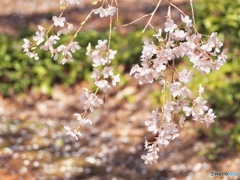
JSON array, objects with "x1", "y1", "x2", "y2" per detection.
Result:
[{"x1": 22, "y1": 0, "x2": 117, "y2": 64}]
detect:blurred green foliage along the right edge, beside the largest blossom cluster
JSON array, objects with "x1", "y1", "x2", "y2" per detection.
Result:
[{"x1": 193, "y1": 0, "x2": 240, "y2": 160}]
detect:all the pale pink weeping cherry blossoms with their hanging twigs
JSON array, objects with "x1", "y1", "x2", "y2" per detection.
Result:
[{"x1": 22, "y1": 0, "x2": 227, "y2": 164}]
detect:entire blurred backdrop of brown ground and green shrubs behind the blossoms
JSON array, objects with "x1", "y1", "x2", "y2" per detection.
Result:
[{"x1": 0, "y1": 0, "x2": 240, "y2": 180}]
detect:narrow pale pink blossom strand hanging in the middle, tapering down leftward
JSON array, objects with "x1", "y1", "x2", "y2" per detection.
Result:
[{"x1": 64, "y1": 40, "x2": 120, "y2": 139}]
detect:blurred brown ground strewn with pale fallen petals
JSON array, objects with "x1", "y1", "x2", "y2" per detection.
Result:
[{"x1": 0, "y1": 0, "x2": 240, "y2": 180}]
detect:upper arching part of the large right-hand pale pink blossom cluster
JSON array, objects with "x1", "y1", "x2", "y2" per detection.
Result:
[{"x1": 130, "y1": 16, "x2": 227, "y2": 84}]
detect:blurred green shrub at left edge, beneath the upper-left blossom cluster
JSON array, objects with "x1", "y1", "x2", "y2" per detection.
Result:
[{"x1": 0, "y1": 32, "x2": 87, "y2": 95}]
